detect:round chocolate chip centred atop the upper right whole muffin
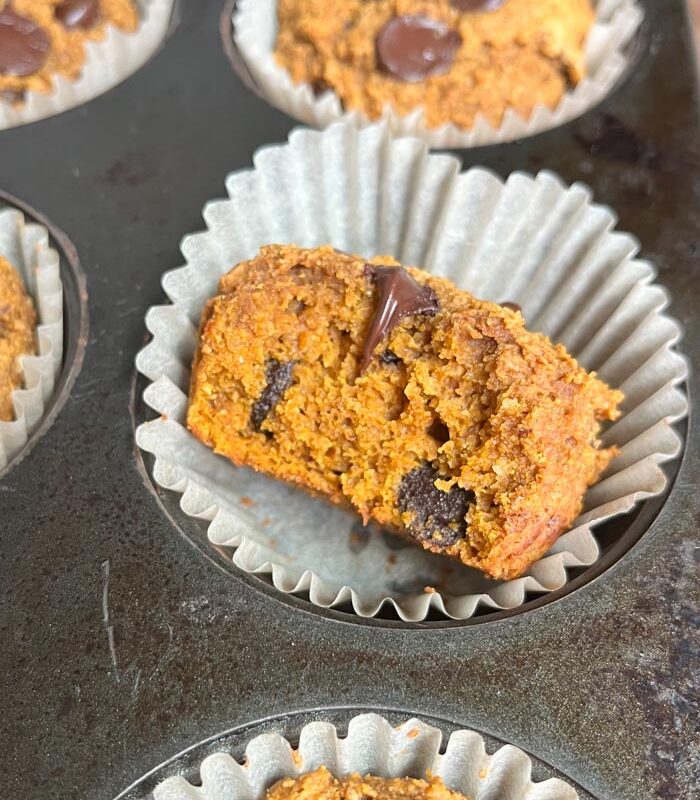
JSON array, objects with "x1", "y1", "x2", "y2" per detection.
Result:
[{"x1": 376, "y1": 15, "x2": 462, "y2": 83}]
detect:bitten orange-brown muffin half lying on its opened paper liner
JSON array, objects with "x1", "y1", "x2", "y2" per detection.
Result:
[{"x1": 188, "y1": 245, "x2": 621, "y2": 579}]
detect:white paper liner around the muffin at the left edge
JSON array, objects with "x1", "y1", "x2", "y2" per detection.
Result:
[{"x1": 0, "y1": 208, "x2": 63, "y2": 472}]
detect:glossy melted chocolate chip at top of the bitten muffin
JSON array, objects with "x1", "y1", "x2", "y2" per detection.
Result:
[{"x1": 360, "y1": 264, "x2": 440, "y2": 373}]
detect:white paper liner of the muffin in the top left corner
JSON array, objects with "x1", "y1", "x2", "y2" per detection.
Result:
[{"x1": 0, "y1": 0, "x2": 174, "y2": 130}]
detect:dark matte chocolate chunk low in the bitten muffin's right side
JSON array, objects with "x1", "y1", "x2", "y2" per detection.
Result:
[{"x1": 397, "y1": 462, "x2": 474, "y2": 547}]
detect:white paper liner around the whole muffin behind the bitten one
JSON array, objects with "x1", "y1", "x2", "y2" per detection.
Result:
[{"x1": 232, "y1": 0, "x2": 644, "y2": 148}]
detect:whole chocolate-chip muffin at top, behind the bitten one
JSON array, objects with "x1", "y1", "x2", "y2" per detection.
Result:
[{"x1": 275, "y1": 0, "x2": 594, "y2": 129}]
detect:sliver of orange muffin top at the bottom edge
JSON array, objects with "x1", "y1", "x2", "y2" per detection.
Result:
[{"x1": 266, "y1": 767, "x2": 469, "y2": 800}]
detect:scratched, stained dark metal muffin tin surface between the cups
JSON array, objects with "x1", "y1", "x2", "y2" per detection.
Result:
[{"x1": 0, "y1": 0, "x2": 700, "y2": 800}]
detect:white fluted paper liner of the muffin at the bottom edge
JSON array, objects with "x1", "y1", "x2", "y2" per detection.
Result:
[{"x1": 153, "y1": 714, "x2": 579, "y2": 800}]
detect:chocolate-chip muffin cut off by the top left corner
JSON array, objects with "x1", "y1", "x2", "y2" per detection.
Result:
[{"x1": 0, "y1": 0, "x2": 139, "y2": 103}]
